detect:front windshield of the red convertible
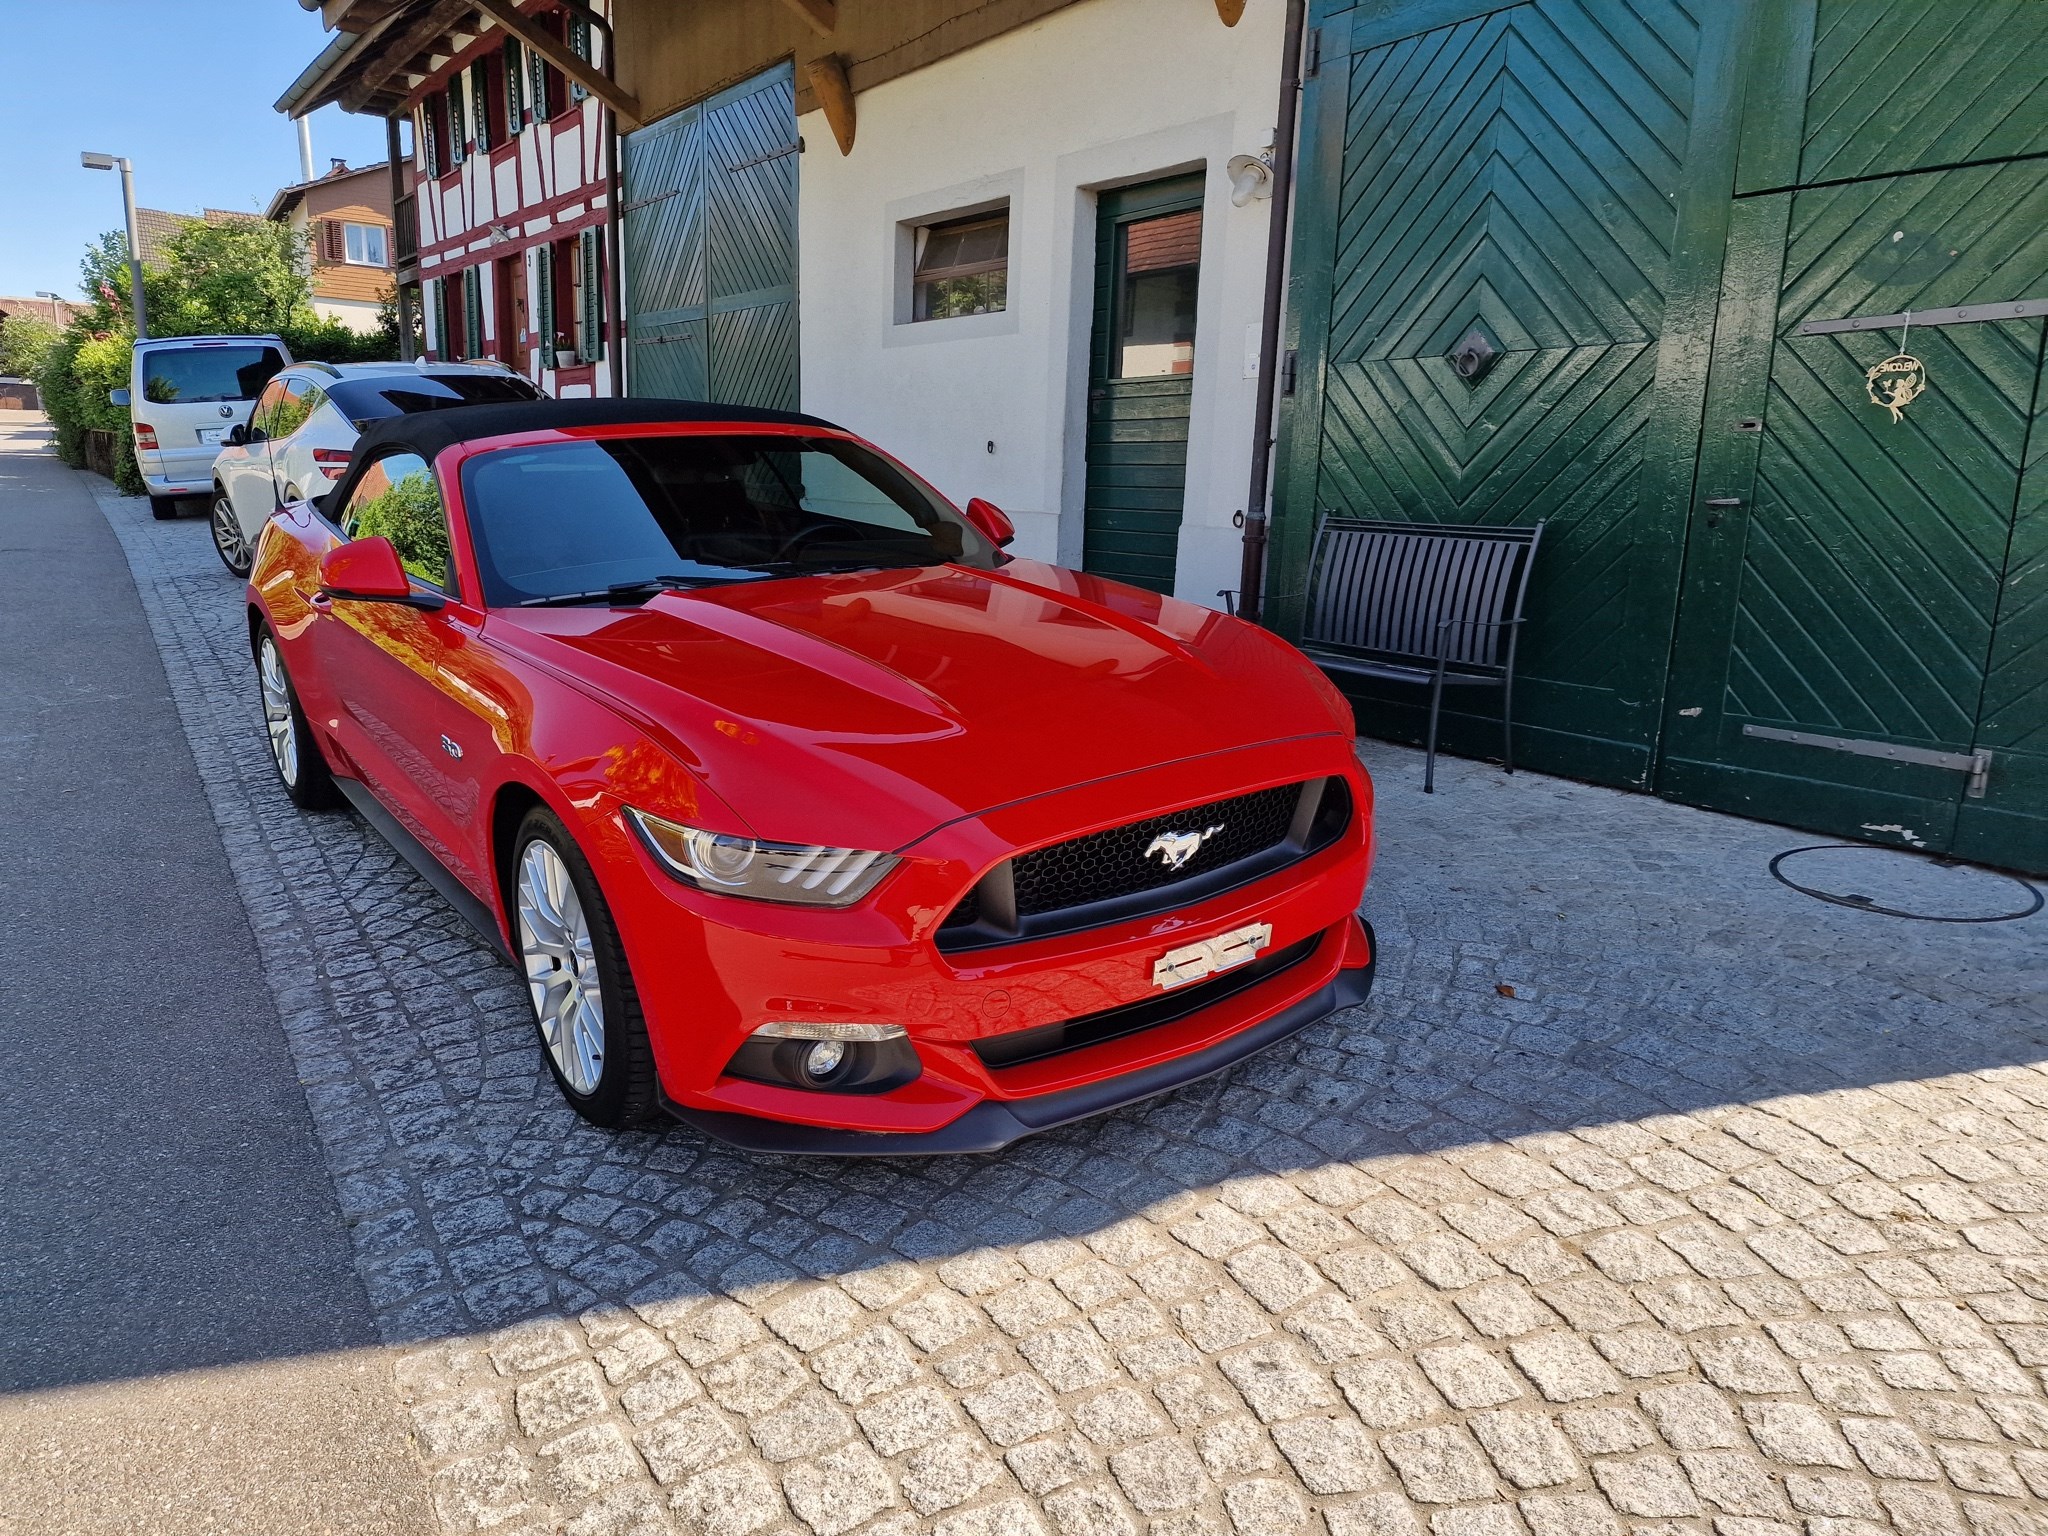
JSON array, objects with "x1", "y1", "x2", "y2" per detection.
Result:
[{"x1": 463, "y1": 432, "x2": 997, "y2": 606}]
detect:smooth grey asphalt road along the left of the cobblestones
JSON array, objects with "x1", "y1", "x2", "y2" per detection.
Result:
[{"x1": 0, "y1": 412, "x2": 424, "y2": 1536}]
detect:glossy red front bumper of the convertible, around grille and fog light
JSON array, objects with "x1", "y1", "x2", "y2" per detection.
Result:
[{"x1": 586, "y1": 735, "x2": 1372, "y2": 1153}]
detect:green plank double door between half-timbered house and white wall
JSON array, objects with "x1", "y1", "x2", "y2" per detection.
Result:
[{"x1": 625, "y1": 63, "x2": 799, "y2": 410}]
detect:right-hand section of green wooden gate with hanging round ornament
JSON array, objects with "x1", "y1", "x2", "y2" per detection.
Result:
[{"x1": 1657, "y1": 0, "x2": 2048, "y2": 868}]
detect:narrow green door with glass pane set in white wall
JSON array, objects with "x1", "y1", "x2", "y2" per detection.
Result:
[{"x1": 1081, "y1": 176, "x2": 1202, "y2": 592}]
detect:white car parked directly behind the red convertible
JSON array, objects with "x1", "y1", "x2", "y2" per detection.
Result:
[{"x1": 213, "y1": 362, "x2": 543, "y2": 575}]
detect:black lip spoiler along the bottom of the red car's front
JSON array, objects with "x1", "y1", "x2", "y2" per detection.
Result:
[{"x1": 664, "y1": 920, "x2": 1378, "y2": 1157}]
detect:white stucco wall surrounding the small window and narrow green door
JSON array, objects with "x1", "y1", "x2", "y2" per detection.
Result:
[{"x1": 799, "y1": 0, "x2": 1284, "y2": 606}]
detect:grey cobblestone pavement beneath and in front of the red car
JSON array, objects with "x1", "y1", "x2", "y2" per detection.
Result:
[{"x1": 88, "y1": 479, "x2": 2048, "y2": 1536}]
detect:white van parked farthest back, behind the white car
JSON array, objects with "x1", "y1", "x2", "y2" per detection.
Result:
[{"x1": 111, "y1": 336, "x2": 291, "y2": 518}]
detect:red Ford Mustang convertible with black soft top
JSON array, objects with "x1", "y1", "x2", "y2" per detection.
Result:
[{"x1": 248, "y1": 401, "x2": 1374, "y2": 1155}]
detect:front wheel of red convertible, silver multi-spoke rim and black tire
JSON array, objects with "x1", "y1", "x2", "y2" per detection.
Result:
[{"x1": 508, "y1": 805, "x2": 664, "y2": 1130}]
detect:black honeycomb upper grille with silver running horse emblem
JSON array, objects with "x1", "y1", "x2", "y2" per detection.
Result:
[{"x1": 938, "y1": 776, "x2": 1352, "y2": 950}]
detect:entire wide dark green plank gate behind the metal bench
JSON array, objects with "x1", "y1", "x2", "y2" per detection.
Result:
[{"x1": 1270, "y1": 0, "x2": 2048, "y2": 868}]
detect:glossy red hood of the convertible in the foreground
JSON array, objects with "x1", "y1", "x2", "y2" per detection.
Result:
[{"x1": 492, "y1": 561, "x2": 1350, "y2": 848}]
